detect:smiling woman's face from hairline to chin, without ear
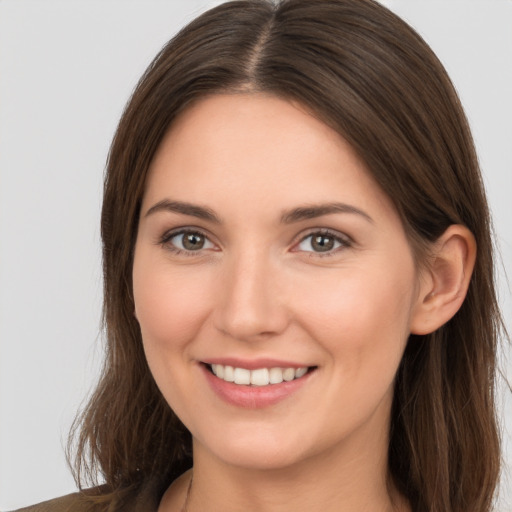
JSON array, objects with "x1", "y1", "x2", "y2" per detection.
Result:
[{"x1": 133, "y1": 94, "x2": 419, "y2": 468}]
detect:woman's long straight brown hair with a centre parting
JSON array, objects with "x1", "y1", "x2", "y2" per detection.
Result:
[{"x1": 68, "y1": 0, "x2": 502, "y2": 512}]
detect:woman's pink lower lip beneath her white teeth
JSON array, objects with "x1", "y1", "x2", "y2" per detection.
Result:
[{"x1": 201, "y1": 364, "x2": 313, "y2": 409}]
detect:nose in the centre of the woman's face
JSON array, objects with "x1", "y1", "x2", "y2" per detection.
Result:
[{"x1": 215, "y1": 251, "x2": 289, "y2": 341}]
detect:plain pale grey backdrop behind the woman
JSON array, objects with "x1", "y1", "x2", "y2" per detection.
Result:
[{"x1": 0, "y1": 0, "x2": 512, "y2": 511}]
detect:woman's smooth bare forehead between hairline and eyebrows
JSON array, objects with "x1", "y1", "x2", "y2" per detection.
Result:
[{"x1": 144, "y1": 94, "x2": 393, "y2": 224}]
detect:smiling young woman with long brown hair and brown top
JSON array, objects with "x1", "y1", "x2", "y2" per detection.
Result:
[{"x1": 16, "y1": 0, "x2": 501, "y2": 512}]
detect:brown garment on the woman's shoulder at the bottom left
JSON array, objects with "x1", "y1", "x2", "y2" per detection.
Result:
[{"x1": 14, "y1": 482, "x2": 161, "y2": 512}]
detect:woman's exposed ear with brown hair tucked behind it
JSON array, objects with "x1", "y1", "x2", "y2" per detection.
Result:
[{"x1": 411, "y1": 224, "x2": 476, "y2": 334}]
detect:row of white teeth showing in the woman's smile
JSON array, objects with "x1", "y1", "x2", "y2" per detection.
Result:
[{"x1": 211, "y1": 364, "x2": 308, "y2": 386}]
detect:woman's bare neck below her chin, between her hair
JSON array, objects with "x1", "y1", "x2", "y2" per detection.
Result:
[{"x1": 182, "y1": 428, "x2": 409, "y2": 512}]
